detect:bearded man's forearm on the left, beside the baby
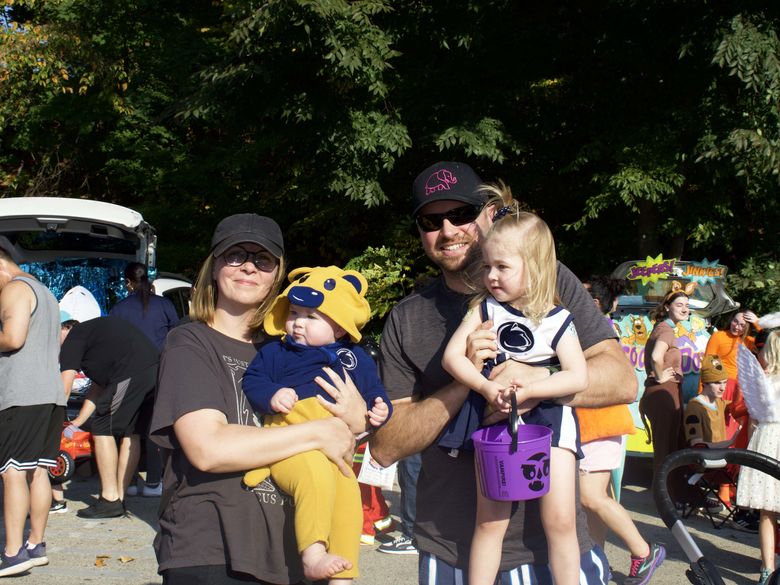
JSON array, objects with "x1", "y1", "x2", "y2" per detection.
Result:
[{"x1": 369, "y1": 382, "x2": 469, "y2": 467}]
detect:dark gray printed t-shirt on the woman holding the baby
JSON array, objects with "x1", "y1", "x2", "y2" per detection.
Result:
[{"x1": 150, "y1": 322, "x2": 303, "y2": 583}]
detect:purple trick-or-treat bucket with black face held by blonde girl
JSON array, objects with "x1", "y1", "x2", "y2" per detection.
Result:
[{"x1": 471, "y1": 396, "x2": 552, "y2": 502}]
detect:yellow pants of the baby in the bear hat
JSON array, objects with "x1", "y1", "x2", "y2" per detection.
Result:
[{"x1": 244, "y1": 398, "x2": 363, "y2": 579}]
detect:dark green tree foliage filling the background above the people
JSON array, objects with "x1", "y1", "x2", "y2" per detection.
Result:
[{"x1": 0, "y1": 0, "x2": 780, "y2": 315}]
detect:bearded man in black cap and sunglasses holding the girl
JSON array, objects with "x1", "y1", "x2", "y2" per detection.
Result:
[{"x1": 371, "y1": 162, "x2": 636, "y2": 585}]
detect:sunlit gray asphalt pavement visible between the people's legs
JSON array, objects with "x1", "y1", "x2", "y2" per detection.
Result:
[{"x1": 0, "y1": 459, "x2": 760, "y2": 585}]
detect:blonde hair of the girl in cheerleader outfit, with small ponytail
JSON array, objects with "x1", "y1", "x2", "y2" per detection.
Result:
[{"x1": 479, "y1": 181, "x2": 560, "y2": 323}]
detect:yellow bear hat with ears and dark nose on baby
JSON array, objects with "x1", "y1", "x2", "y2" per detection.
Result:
[{"x1": 263, "y1": 266, "x2": 371, "y2": 343}]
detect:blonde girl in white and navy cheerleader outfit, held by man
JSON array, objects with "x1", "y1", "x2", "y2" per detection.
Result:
[{"x1": 443, "y1": 184, "x2": 588, "y2": 585}]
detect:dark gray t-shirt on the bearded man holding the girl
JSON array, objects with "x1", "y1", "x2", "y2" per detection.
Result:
[{"x1": 380, "y1": 263, "x2": 615, "y2": 571}]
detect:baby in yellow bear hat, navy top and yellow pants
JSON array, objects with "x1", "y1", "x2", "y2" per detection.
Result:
[{"x1": 243, "y1": 266, "x2": 391, "y2": 580}]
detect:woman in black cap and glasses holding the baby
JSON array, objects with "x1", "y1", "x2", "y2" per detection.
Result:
[{"x1": 151, "y1": 214, "x2": 365, "y2": 585}]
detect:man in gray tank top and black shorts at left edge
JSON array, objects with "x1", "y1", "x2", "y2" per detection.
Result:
[{"x1": 0, "y1": 236, "x2": 65, "y2": 577}]
